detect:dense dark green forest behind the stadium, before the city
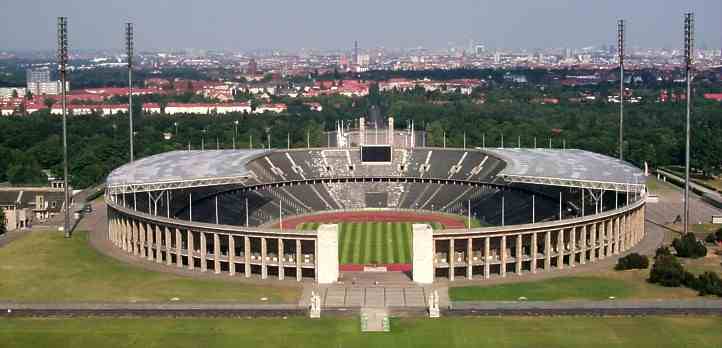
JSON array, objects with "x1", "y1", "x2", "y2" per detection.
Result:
[{"x1": 0, "y1": 78, "x2": 722, "y2": 187}]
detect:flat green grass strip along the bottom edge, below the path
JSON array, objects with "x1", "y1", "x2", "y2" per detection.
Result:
[{"x1": 0, "y1": 316, "x2": 722, "y2": 348}]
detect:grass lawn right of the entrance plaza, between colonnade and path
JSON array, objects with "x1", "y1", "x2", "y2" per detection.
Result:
[{"x1": 449, "y1": 270, "x2": 699, "y2": 301}]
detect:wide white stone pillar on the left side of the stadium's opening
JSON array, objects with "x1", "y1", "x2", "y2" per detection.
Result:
[{"x1": 315, "y1": 225, "x2": 339, "y2": 284}]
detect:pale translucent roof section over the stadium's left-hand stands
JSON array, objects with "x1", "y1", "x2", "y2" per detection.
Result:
[{"x1": 106, "y1": 150, "x2": 268, "y2": 193}]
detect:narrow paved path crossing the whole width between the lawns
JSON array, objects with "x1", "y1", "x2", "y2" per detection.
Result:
[{"x1": 0, "y1": 299, "x2": 722, "y2": 317}]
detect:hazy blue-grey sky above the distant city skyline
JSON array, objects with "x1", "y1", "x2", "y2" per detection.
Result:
[{"x1": 0, "y1": 0, "x2": 722, "y2": 51}]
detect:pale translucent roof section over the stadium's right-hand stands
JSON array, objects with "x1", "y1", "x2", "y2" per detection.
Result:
[{"x1": 484, "y1": 148, "x2": 645, "y2": 191}]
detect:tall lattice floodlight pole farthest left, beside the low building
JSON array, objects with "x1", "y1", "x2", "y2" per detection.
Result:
[{"x1": 58, "y1": 17, "x2": 70, "y2": 238}]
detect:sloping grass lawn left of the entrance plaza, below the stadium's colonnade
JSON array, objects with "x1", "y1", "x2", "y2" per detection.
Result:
[{"x1": 0, "y1": 231, "x2": 300, "y2": 302}]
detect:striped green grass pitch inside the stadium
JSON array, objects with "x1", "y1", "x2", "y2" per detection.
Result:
[{"x1": 298, "y1": 222, "x2": 441, "y2": 265}]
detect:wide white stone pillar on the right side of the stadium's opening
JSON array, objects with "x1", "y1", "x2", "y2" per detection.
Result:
[{"x1": 411, "y1": 224, "x2": 435, "y2": 284}]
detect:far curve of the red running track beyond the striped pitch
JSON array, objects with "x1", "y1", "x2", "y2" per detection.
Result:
[{"x1": 274, "y1": 211, "x2": 466, "y2": 228}]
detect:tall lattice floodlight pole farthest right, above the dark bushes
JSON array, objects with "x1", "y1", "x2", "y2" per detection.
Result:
[{"x1": 684, "y1": 12, "x2": 694, "y2": 234}]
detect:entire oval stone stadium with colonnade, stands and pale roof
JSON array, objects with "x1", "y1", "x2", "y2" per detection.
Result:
[{"x1": 105, "y1": 119, "x2": 646, "y2": 284}]
